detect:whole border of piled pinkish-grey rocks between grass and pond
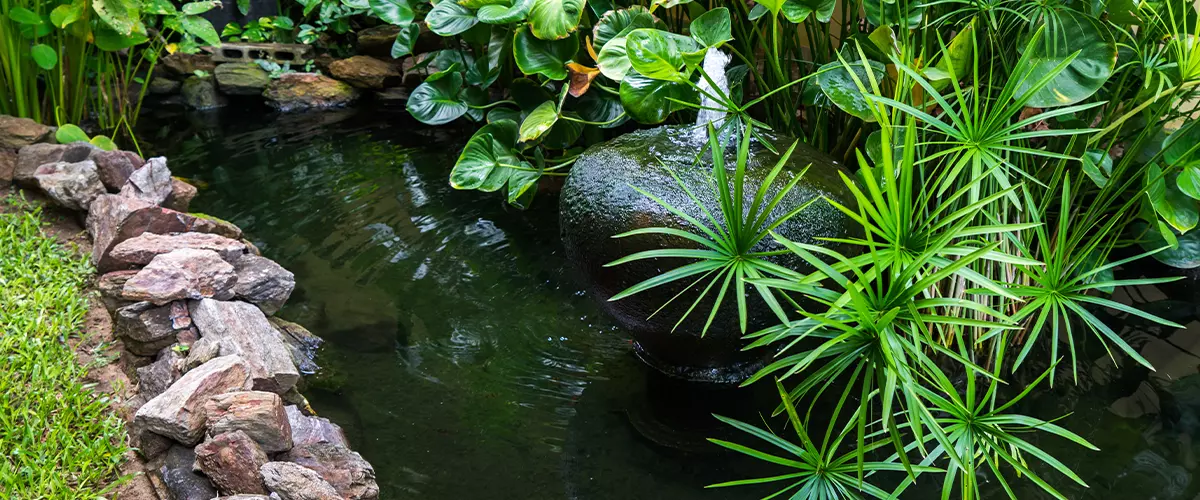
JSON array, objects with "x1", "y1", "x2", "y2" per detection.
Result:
[{"x1": 0, "y1": 115, "x2": 379, "y2": 500}]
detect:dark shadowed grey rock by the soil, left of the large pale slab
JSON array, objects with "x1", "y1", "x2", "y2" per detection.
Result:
[{"x1": 113, "y1": 301, "x2": 192, "y2": 356}]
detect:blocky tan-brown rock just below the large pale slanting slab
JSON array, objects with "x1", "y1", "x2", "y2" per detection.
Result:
[{"x1": 204, "y1": 391, "x2": 292, "y2": 453}]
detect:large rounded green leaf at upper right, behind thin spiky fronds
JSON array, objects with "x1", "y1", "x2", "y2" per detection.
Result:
[{"x1": 1016, "y1": 8, "x2": 1117, "y2": 108}]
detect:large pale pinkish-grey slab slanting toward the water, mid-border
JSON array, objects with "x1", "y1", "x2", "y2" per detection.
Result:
[{"x1": 190, "y1": 299, "x2": 300, "y2": 393}]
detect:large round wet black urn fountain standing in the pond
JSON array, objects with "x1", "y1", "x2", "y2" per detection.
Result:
[{"x1": 559, "y1": 127, "x2": 854, "y2": 382}]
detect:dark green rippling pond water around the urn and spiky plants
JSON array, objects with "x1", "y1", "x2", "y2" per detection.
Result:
[{"x1": 140, "y1": 108, "x2": 1200, "y2": 500}]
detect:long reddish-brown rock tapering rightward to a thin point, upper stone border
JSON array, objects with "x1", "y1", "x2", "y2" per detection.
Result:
[{"x1": 86, "y1": 194, "x2": 241, "y2": 272}]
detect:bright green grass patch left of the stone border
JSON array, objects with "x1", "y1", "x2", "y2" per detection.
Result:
[{"x1": 0, "y1": 197, "x2": 127, "y2": 499}]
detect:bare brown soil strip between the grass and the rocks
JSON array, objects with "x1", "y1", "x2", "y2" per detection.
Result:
[{"x1": 0, "y1": 187, "x2": 163, "y2": 500}]
